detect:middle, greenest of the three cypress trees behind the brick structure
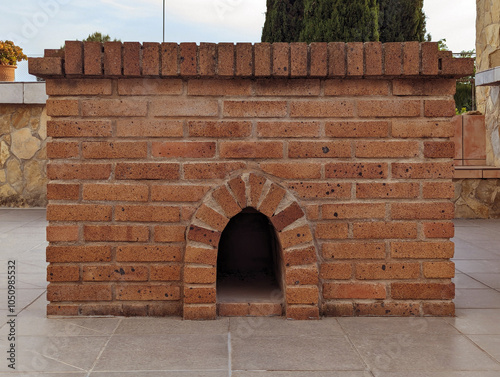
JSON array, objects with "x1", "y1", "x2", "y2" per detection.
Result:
[{"x1": 299, "y1": 0, "x2": 379, "y2": 43}]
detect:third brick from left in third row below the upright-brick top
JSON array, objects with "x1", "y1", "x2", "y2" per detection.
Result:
[{"x1": 187, "y1": 121, "x2": 252, "y2": 139}]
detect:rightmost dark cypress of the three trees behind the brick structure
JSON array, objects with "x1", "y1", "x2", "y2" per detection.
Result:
[{"x1": 378, "y1": 0, "x2": 426, "y2": 43}]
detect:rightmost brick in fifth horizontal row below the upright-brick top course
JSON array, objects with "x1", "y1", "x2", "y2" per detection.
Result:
[{"x1": 392, "y1": 162, "x2": 454, "y2": 179}]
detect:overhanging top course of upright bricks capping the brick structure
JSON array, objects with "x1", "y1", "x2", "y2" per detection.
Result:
[{"x1": 29, "y1": 41, "x2": 474, "y2": 78}]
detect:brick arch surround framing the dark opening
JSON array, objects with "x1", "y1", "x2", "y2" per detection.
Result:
[{"x1": 183, "y1": 173, "x2": 319, "y2": 319}]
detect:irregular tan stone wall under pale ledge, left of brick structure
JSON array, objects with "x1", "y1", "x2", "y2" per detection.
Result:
[{"x1": 0, "y1": 104, "x2": 47, "y2": 207}]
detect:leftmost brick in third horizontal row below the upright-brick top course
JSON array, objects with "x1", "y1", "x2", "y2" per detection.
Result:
[{"x1": 47, "y1": 120, "x2": 112, "y2": 137}]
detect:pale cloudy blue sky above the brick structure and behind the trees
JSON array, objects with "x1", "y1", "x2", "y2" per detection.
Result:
[{"x1": 0, "y1": 0, "x2": 476, "y2": 78}]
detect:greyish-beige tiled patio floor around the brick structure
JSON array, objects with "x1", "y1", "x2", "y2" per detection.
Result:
[{"x1": 0, "y1": 209, "x2": 500, "y2": 377}]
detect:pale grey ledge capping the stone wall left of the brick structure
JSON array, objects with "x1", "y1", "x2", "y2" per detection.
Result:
[{"x1": 0, "y1": 82, "x2": 49, "y2": 104}]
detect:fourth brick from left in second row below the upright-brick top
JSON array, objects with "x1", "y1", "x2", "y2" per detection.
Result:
[{"x1": 222, "y1": 101, "x2": 287, "y2": 118}]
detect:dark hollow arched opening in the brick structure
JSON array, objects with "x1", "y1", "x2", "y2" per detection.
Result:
[{"x1": 217, "y1": 207, "x2": 282, "y2": 304}]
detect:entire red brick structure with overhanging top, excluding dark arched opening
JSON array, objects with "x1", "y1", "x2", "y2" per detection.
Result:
[{"x1": 30, "y1": 42, "x2": 472, "y2": 319}]
